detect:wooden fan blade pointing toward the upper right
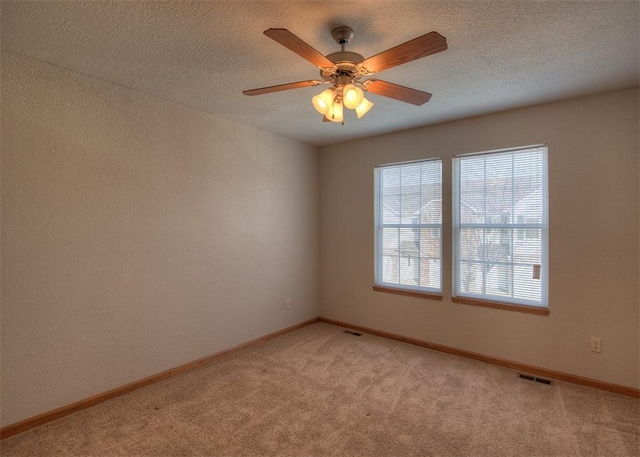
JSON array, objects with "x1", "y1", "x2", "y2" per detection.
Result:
[{"x1": 360, "y1": 32, "x2": 447, "y2": 73}]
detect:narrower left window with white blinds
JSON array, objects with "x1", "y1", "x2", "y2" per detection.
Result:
[{"x1": 375, "y1": 160, "x2": 442, "y2": 294}]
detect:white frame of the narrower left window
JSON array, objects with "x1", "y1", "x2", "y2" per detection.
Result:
[{"x1": 374, "y1": 158, "x2": 443, "y2": 299}]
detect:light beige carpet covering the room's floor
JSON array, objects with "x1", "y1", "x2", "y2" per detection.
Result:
[{"x1": 0, "y1": 323, "x2": 640, "y2": 457}]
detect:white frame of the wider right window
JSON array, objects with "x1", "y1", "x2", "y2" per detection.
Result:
[{"x1": 452, "y1": 144, "x2": 549, "y2": 309}]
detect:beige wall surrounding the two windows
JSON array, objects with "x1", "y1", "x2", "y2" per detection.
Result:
[{"x1": 320, "y1": 88, "x2": 640, "y2": 388}]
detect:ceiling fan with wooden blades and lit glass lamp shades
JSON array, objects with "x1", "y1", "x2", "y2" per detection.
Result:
[{"x1": 242, "y1": 26, "x2": 447, "y2": 123}]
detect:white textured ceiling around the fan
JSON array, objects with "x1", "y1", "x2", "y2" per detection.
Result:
[{"x1": 1, "y1": 0, "x2": 640, "y2": 145}]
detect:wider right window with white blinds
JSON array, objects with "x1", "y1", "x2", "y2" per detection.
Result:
[{"x1": 453, "y1": 146, "x2": 548, "y2": 308}]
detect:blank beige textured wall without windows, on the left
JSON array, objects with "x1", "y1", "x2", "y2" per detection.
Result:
[{"x1": 1, "y1": 54, "x2": 319, "y2": 425}]
